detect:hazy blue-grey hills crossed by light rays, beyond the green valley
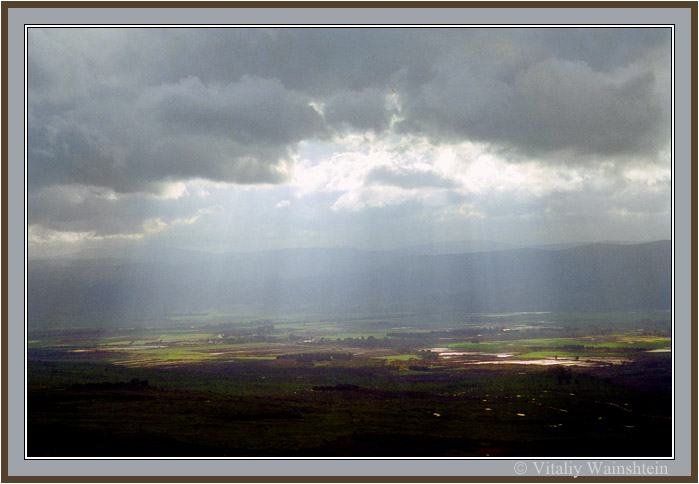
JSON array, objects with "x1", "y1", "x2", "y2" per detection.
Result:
[{"x1": 28, "y1": 241, "x2": 671, "y2": 328}]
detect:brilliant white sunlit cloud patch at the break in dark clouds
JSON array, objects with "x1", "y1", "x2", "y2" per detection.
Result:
[{"x1": 290, "y1": 134, "x2": 609, "y2": 214}]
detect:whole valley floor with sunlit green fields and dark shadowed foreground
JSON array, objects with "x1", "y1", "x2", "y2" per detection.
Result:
[{"x1": 27, "y1": 313, "x2": 672, "y2": 457}]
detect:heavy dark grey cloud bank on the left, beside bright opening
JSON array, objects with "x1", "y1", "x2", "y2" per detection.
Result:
[{"x1": 28, "y1": 73, "x2": 323, "y2": 192}]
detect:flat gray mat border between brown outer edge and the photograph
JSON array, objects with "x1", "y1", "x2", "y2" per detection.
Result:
[{"x1": 5, "y1": 4, "x2": 692, "y2": 477}]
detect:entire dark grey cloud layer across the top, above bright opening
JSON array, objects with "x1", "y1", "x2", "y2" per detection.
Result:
[{"x1": 28, "y1": 28, "x2": 669, "y2": 195}]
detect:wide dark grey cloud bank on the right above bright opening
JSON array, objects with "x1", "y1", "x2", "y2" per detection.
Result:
[{"x1": 401, "y1": 51, "x2": 670, "y2": 161}]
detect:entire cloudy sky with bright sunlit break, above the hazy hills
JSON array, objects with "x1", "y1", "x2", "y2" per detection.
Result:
[{"x1": 27, "y1": 28, "x2": 671, "y2": 257}]
